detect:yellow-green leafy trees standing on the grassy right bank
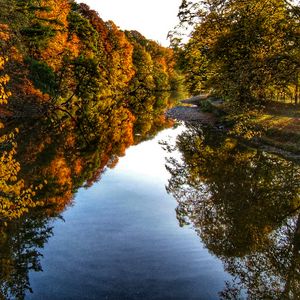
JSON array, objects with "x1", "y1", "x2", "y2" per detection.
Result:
[{"x1": 171, "y1": 0, "x2": 300, "y2": 104}]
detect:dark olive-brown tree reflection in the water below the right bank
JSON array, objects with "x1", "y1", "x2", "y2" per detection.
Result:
[{"x1": 167, "y1": 125, "x2": 300, "y2": 299}]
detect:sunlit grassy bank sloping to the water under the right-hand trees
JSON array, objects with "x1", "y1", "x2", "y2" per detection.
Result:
[{"x1": 193, "y1": 98, "x2": 300, "y2": 160}]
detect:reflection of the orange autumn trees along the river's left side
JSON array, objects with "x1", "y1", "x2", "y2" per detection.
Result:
[{"x1": 0, "y1": 94, "x2": 172, "y2": 299}]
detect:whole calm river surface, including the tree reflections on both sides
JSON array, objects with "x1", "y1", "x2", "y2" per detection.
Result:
[{"x1": 0, "y1": 118, "x2": 300, "y2": 299}]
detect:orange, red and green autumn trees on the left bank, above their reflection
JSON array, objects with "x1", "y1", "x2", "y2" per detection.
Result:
[{"x1": 0, "y1": 0, "x2": 178, "y2": 119}]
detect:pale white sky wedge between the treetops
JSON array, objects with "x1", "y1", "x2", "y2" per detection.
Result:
[{"x1": 77, "y1": 0, "x2": 181, "y2": 46}]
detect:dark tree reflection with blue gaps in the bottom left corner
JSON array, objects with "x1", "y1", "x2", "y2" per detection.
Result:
[{"x1": 0, "y1": 211, "x2": 58, "y2": 299}]
